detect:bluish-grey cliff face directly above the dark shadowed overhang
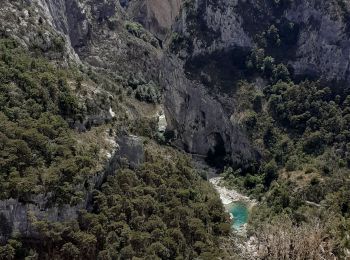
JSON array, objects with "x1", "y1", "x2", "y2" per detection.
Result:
[{"x1": 176, "y1": 0, "x2": 253, "y2": 55}]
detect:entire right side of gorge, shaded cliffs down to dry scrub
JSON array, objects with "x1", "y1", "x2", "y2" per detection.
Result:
[{"x1": 165, "y1": 0, "x2": 350, "y2": 259}]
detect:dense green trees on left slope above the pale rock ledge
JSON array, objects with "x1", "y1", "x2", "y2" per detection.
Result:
[{"x1": 0, "y1": 39, "x2": 98, "y2": 202}]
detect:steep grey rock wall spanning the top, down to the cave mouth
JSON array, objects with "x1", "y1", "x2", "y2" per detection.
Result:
[{"x1": 6, "y1": 0, "x2": 350, "y2": 189}]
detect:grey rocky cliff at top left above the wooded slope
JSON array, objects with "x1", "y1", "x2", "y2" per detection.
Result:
[{"x1": 0, "y1": 0, "x2": 165, "y2": 80}]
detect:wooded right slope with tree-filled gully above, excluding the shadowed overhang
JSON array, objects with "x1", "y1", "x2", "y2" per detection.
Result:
[{"x1": 219, "y1": 12, "x2": 350, "y2": 259}]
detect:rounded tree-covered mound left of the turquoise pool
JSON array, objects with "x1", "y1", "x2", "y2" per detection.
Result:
[{"x1": 10, "y1": 143, "x2": 230, "y2": 259}]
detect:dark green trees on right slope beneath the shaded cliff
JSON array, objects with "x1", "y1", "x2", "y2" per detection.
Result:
[{"x1": 237, "y1": 79, "x2": 350, "y2": 188}]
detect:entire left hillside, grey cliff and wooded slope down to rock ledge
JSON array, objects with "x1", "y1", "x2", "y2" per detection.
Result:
[{"x1": 0, "y1": 1, "x2": 160, "y2": 242}]
